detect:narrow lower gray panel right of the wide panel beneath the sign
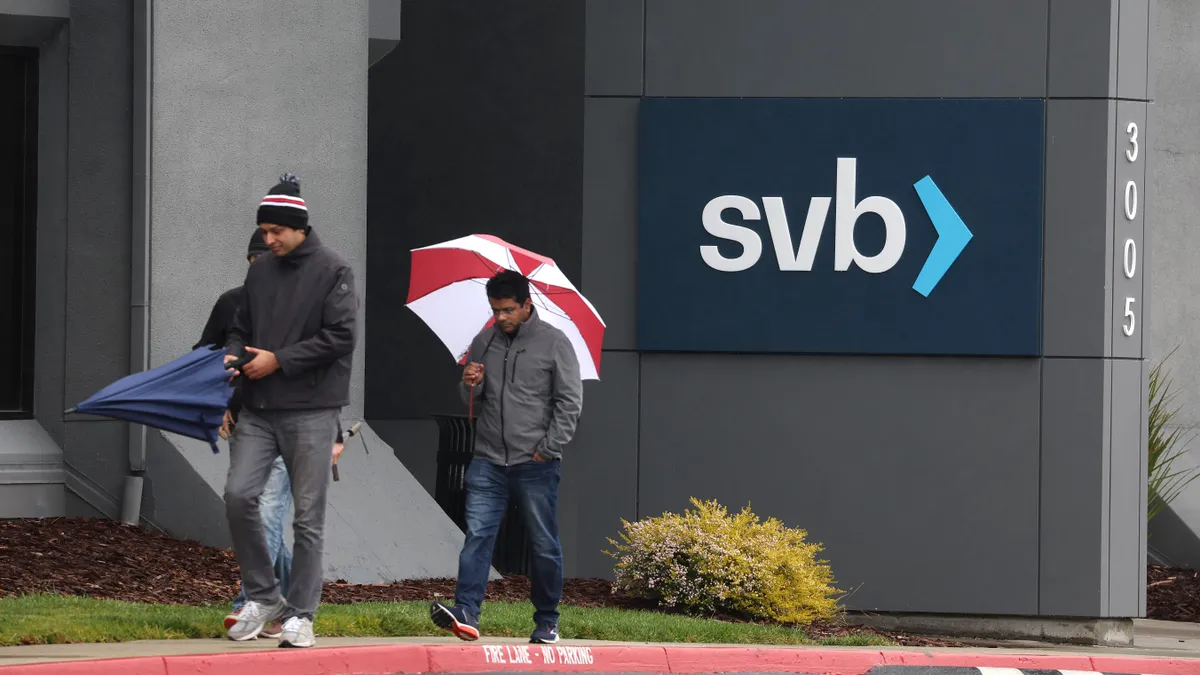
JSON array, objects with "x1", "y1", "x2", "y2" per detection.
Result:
[{"x1": 1039, "y1": 358, "x2": 1111, "y2": 616}]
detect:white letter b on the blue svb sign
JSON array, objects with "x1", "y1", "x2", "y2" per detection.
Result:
[{"x1": 833, "y1": 157, "x2": 907, "y2": 274}]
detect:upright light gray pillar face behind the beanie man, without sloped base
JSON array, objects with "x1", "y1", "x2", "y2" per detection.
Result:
[{"x1": 150, "y1": 0, "x2": 368, "y2": 416}]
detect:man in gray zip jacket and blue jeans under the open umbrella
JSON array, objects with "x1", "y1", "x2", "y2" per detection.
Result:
[{"x1": 430, "y1": 270, "x2": 583, "y2": 644}]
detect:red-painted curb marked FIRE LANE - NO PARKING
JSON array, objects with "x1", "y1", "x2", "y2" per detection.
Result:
[{"x1": 0, "y1": 644, "x2": 1200, "y2": 675}]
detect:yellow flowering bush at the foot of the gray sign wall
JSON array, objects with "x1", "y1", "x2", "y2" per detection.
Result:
[{"x1": 605, "y1": 497, "x2": 841, "y2": 625}]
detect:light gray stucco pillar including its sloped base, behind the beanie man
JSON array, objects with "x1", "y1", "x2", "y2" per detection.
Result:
[{"x1": 143, "y1": 0, "x2": 462, "y2": 583}]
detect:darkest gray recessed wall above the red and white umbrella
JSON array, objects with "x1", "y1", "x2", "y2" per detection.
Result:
[{"x1": 366, "y1": 0, "x2": 588, "y2": 419}]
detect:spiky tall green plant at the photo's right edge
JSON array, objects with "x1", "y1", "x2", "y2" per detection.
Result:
[{"x1": 1146, "y1": 347, "x2": 1200, "y2": 521}]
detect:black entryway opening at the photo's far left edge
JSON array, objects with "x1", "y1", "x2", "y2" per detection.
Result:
[{"x1": 0, "y1": 50, "x2": 37, "y2": 419}]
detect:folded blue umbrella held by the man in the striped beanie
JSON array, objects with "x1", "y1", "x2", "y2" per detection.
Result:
[{"x1": 66, "y1": 347, "x2": 234, "y2": 453}]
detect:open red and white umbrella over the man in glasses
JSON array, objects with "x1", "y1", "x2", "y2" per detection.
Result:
[{"x1": 406, "y1": 234, "x2": 605, "y2": 380}]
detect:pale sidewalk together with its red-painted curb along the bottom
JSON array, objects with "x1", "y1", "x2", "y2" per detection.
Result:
[{"x1": 0, "y1": 622, "x2": 1200, "y2": 675}]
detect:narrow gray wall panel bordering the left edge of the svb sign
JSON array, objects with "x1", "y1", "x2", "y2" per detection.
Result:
[{"x1": 580, "y1": 98, "x2": 637, "y2": 353}]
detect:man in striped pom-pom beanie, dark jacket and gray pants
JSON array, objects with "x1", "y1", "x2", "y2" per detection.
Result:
[{"x1": 224, "y1": 174, "x2": 359, "y2": 647}]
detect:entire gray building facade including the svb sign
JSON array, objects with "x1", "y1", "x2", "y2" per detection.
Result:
[{"x1": 0, "y1": 0, "x2": 1200, "y2": 617}]
